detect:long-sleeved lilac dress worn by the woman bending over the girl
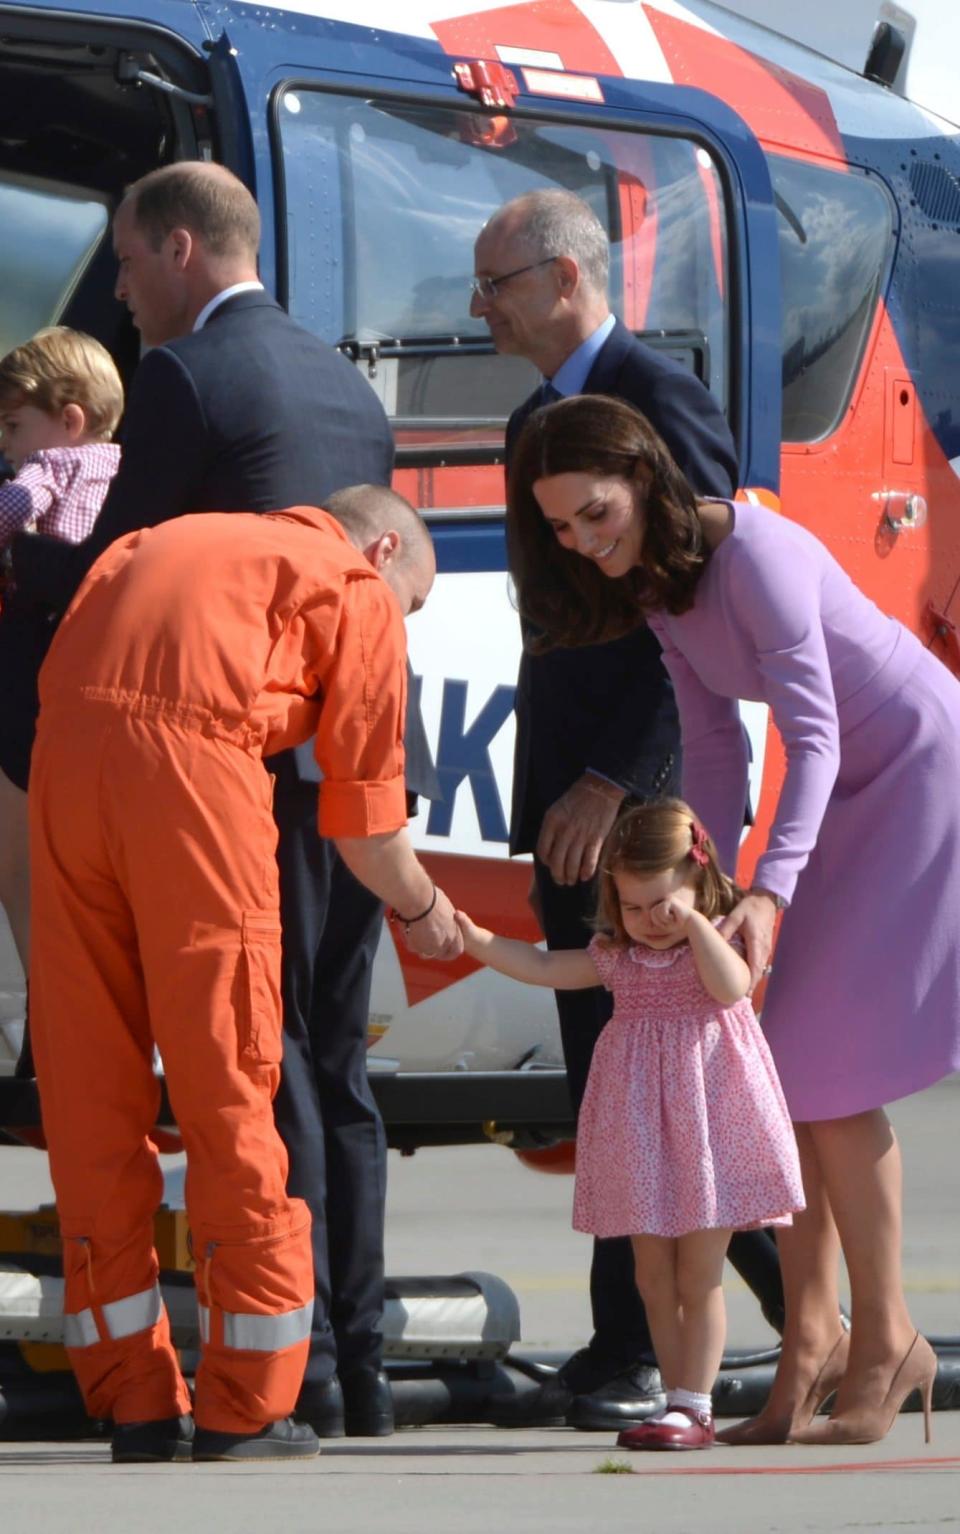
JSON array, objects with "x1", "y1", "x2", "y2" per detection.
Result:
[{"x1": 650, "y1": 502, "x2": 960, "y2": 1123}]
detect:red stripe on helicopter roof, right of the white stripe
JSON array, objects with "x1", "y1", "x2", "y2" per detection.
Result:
[{"x1": 644, "y1": 5, "x2": 847, "y2": 161}]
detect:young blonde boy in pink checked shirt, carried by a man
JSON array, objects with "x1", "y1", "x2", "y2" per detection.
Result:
[{"x1": 0, "y1": 325, "x2": 123, "y2": 994}]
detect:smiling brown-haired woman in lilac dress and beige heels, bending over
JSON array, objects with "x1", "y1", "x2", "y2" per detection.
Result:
[{"x1": 508, "y1": 396, "x2": 960, "y2": 1443}]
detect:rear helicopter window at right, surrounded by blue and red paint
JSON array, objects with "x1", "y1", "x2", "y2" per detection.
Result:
[{"x1": 770, "y1": 155, "x2": 893, "y2": 442}]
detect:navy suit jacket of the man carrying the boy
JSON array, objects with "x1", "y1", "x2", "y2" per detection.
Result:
[{"x1": 0, "y1": 290, "x2": 436, "y2": 793}]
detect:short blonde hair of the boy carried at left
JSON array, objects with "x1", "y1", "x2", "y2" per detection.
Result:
[{"x1": 0, "y1": 325, "x2": 123, "y2": 442}]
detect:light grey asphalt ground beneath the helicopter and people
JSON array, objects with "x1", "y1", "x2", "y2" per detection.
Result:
[{"x1": 0, "y1": 1077, "x2": 960, "y2": 1534}]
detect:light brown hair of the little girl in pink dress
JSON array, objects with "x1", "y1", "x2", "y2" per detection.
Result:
[{"x1": 597, "y1": 799, "x2": 742, "y2": 946}]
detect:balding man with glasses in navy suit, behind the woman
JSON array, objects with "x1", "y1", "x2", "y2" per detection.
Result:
[{"x1": 471, "y1": 190, "x2": 748, "y2": 1428}]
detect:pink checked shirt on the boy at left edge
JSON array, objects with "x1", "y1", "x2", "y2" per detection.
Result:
[{"x1": 0, "y1": 442, "x2": 120, "y2": 549}]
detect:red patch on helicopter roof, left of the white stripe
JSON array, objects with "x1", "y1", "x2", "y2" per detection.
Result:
[{"x1": 431, "y1": 0, "x2": 623, "y2": 75}]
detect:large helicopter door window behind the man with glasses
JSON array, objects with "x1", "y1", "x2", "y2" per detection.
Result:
[{"x1": 276, "y1": 86, "x2": 728, "y2": 462}]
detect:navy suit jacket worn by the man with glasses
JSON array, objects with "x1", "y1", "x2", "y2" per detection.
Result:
[{"x1": 506, "y1": 321, "x2": 738, "y2": 853}]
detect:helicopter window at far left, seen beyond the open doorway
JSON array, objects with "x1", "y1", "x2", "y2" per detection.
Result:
[{"x1": 0, "y1": 172, "x2": 109, "y2": 356}]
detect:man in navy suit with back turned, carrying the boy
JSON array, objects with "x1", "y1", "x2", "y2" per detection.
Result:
[{"x1": 14, "y1": 161, "x2": 444, "y2": 1436}]
